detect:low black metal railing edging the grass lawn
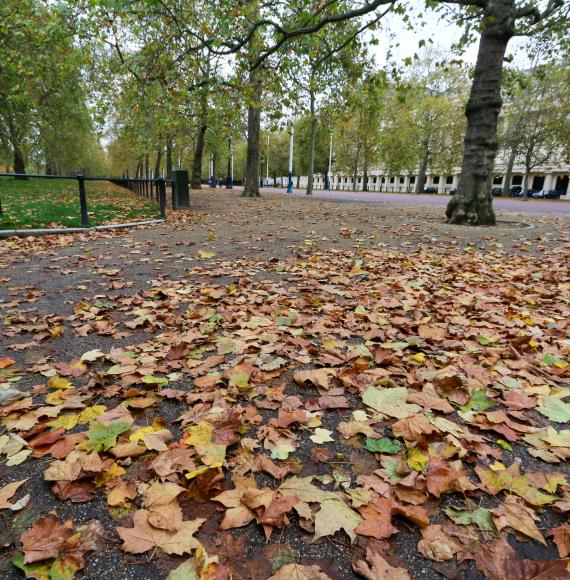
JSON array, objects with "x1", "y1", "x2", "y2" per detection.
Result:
[{"x1": 0, "y1": 173, "x2": 170, "y2": 228}]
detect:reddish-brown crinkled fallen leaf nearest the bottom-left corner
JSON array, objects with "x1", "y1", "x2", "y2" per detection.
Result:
[{"x1": 20, "y1": 514, "x2": 73, "y2": 564}]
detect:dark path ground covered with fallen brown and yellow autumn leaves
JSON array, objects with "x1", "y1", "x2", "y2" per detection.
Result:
[{"x1": 0, "y1": 192, "x2": 570, "y2": 579}]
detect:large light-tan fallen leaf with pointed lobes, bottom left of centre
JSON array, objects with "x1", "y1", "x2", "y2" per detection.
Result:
[{"x1": 116, "y1": 510, "x2": 206, "y2": 556}]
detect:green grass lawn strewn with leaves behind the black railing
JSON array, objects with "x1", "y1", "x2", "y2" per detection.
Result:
[{"x1": 0, "y1": 178, "x2": 159, "y2": 229}]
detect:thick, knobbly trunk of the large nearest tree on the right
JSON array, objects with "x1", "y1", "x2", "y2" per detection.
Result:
[{"x1": 446, "y1": 0, "x2": 515, "y2": 225}]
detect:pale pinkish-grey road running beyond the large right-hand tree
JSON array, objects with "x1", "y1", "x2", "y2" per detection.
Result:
[{"x1": 255, "y1": 187, "x2": 570, "y2": 214}]
